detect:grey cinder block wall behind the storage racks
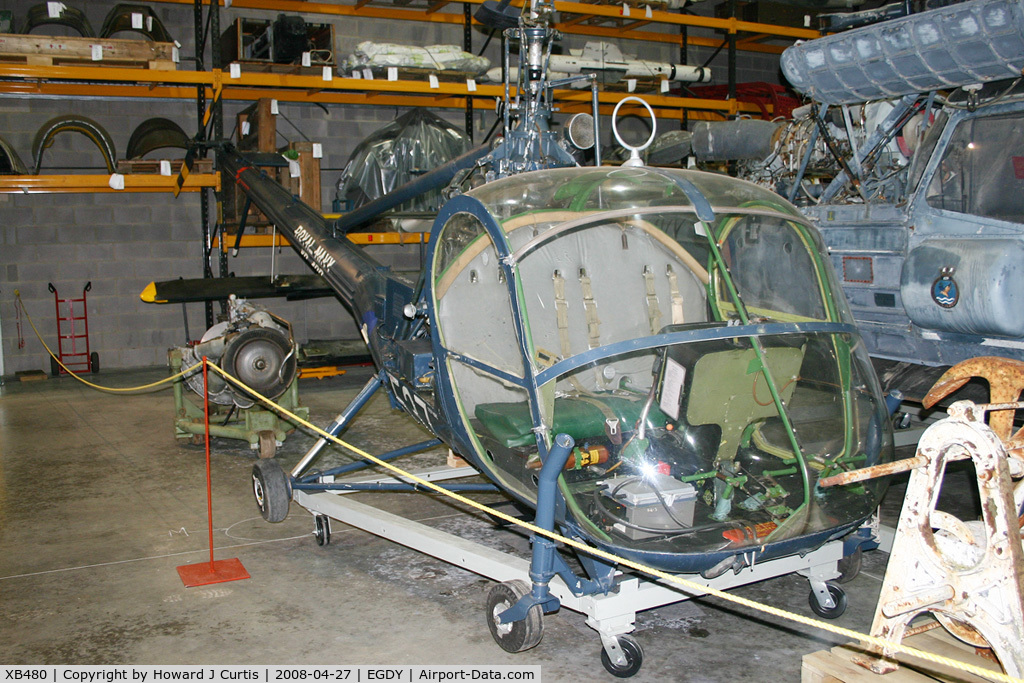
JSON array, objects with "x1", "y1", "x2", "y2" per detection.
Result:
[{"x1": 0, "y1": 0, "x2": 777, "y2": 375}]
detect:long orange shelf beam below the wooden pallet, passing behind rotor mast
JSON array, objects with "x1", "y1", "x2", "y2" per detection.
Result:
[{"x1": 0, "y1": 63, "x2": 760, "y2": 119}]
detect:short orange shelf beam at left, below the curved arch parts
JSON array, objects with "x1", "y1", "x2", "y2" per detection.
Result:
[{"x1": 0, "y1": 173, "x2": 220, "y2": 195}]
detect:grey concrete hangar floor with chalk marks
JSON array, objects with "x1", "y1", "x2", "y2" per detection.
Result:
[{"x1": 0, "y1": 362, "x2": 925, "y2": 683}]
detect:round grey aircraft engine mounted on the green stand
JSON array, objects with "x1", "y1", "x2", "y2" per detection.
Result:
[{"x1": 175, "y1": 295, "x2": 298, "y2": 408}]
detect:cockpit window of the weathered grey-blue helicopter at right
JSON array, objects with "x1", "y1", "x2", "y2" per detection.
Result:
[{"x1": 926, "y1": 112, "x2": 1024, "y2": 223}]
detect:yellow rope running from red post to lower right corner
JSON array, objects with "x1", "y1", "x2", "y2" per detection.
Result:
[{"x1": 210, "y1": 364, "x2": 1024, "y2": 683}]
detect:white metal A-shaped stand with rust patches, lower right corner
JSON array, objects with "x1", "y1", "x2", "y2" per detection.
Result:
[{"x1": 858, "y1": 395, "x2": 1024, "y2": 677}]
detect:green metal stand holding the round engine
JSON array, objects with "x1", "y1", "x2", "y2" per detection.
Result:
[{"x1": 167, "y1": 348, "x2": 309, "y2": 458}]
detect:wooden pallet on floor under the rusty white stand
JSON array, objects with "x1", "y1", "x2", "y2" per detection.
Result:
[{"x1": 800, "y1": 628, "x2": 1001, "y2": 683}]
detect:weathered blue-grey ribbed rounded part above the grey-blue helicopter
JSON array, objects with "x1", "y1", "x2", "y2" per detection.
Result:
[{"x1": 781, "y1": 0, "x2": 1024, "y2": 104}]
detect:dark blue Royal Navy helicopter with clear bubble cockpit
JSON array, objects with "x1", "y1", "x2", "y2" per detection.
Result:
[{"x1": 199, "y1": 0, "x2": 893, "y2": 677}]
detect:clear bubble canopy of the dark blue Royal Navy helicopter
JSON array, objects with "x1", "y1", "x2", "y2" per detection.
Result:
[{"x1": 428, "y1": 167, "x2": 893, "y2": 571}]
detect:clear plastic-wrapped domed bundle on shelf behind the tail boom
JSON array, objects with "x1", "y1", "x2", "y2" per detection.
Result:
[{"x1": 338, "y1": 109, "x2": 470, "y2": 212}]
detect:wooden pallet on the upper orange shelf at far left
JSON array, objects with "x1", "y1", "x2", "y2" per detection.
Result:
[{"x1": 0, "y1": 34, "x2": 177, "y2": 71}]
